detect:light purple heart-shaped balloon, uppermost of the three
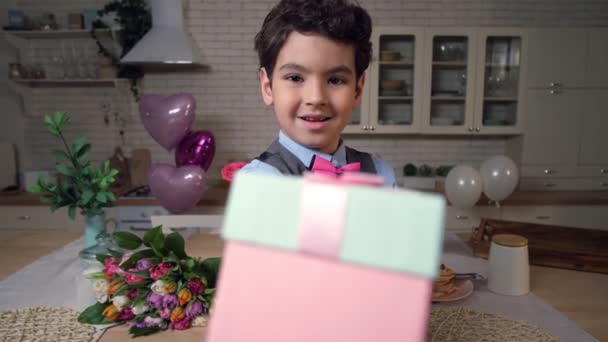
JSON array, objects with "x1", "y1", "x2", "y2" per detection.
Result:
[{"x1": 139, "y1": 93, "x2": 196, "y2": 151}]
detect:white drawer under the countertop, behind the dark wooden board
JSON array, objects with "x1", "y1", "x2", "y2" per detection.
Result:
[{"x1": 501, "y1": 206, "x2": 608, "y2": 230}]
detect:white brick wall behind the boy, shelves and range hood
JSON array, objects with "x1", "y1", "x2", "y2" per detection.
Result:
[{"x1": 8, "y1": 0, "x2": 608, "y2": 184}]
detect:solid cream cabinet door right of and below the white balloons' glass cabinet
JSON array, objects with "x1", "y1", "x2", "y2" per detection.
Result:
[{"x1": 522, "y1": 89, "x2": 584, "y2": 165}]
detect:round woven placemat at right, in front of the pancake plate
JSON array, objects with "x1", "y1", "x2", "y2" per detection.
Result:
[{"x1": 427, "y1": 307, "x2": 557, "y2": 342}]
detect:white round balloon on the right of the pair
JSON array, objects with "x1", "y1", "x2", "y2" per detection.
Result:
[{"x1": 480, "y1": 156, "x2": 519, "y2": 202}]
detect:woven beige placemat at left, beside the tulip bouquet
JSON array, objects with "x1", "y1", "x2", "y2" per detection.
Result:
[{"x1": 0, "y1": 307, "x2": 95, "y2": 342}]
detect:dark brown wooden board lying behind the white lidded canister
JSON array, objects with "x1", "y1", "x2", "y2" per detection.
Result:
[{"x1": 469, "y1": 218, "x2": 608, "y2": 274}]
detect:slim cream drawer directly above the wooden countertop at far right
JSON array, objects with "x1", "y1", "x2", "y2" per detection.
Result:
[{"x1": 519, "y1": 177, "x2": 608, "y2": 191}]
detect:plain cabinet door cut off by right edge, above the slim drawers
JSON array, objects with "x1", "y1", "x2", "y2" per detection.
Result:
[{"x1": 579, "y1": 90, "x2": 608, "y2": 165}]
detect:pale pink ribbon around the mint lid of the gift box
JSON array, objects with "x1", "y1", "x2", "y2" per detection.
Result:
[{"x1": 298, "y1": 173, "x2": 383, "y2": 259}]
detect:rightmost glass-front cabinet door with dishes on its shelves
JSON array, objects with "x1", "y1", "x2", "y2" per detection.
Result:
[{"x1": 474, "y1": 29, "x2": 527, "y2": 134}]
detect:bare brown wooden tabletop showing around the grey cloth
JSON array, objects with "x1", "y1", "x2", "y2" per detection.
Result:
[{"x1": 0, "y1": 230, "x2": 608, "y2": 342}]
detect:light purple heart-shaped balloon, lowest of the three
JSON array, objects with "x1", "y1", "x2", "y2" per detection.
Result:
[{"x1": 148, "y1": 164, "x2": 207, "y2": 214}]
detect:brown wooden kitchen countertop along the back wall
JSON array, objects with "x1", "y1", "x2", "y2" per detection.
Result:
[{"x1": 0, "y1": 187, "x2": 608, "y2": 206}]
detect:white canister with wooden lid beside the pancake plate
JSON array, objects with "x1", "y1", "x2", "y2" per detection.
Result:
[{"x1": 488, "y1": 234, "x2": 530, "y2": 296}]
